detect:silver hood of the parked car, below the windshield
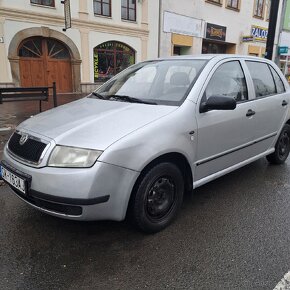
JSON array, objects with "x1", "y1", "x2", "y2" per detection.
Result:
[{"x1": 17, "y1": 97, "x2": 176, "y2": 150}]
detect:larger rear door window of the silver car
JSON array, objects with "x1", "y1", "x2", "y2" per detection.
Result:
[{"x1": 246, "y1": 61, "x2": 276, "y2": 98}]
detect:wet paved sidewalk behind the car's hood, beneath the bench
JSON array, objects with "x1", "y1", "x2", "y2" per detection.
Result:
[{"x1": 0, "y1": 93, "x2": 85, "y2": 160}]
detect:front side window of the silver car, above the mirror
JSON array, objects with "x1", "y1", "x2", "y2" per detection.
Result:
[{"x1": 205, "y1": 61, "x2": 248, "y2": 102}]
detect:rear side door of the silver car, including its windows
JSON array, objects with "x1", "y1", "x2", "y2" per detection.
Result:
[{"x1": 245, "y1": 60, "x2": 290, "y2": 153}]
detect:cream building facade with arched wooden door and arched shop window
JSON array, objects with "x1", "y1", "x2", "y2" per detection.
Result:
[{"x1": 0, "y1": 0, "x2": 159, "y2": 93}]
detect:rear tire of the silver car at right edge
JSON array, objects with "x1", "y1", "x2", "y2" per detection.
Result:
[{"x1": 266, "y1": 124, "x2": 290, "y2": 164}]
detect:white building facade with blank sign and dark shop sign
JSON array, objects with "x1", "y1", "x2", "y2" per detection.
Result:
[{"x1": 159, "y1": 0, "x2": 270, "y2": 56}]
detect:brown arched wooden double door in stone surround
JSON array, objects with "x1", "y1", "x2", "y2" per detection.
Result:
[{"x1": 19, "y1": 37, "x2": 72, "y2": 93}]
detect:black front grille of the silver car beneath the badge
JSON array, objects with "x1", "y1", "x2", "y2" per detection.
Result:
[{"x1": 8, "y1": 132, "x2": 47, "y2": 163}]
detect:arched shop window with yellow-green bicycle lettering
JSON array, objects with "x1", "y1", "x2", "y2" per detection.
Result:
[{"x1": 94, "y1": 41, "x2": 135, "y2": 82}]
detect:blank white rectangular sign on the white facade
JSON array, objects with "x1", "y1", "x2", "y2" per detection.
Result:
[{"x1": 163, "y1": 11, "x2": 203, "y2": 37}]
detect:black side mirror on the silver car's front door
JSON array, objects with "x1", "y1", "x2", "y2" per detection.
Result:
[{"x1": 200, "y1": 95, "x2": 237, "y2": 113}]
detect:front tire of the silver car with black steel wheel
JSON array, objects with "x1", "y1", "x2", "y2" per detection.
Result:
[{"x1": 131, "y1": 162, "x2": 184, "y2": 233}]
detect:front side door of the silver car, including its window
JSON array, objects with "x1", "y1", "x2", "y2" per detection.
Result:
[{"x1": 194, "y1": 59, "x2": 255, "y2": 181}]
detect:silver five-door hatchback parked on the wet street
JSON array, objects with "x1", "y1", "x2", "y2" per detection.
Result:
[{"x1": 1, "y1": 55, "x2": 290, "y2": 233}]
